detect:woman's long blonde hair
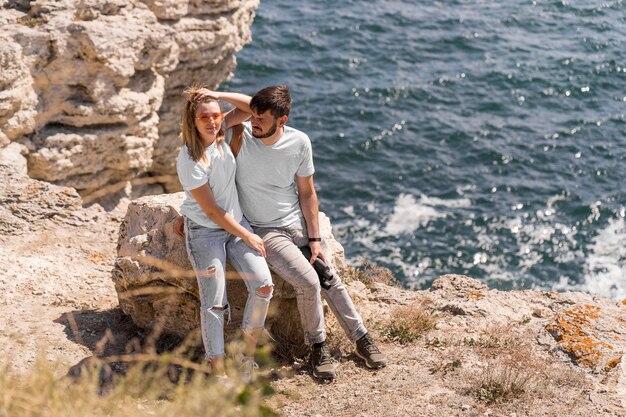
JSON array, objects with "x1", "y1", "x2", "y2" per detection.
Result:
[{"x1": 180, "y1": 85, "x2": 226, "y2": 163}]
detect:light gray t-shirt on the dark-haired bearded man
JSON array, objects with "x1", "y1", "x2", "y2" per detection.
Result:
[{"x1": 237, "y1": 122, "x2": 315, "y2": 227}]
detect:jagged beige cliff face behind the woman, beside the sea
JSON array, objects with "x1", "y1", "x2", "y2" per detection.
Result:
[{"x1": 0, "y1": 0, "x2": 258, "y2": 195}]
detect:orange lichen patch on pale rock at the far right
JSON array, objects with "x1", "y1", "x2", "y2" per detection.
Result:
[{"x1": 546, "y1": 304, "x2": 622, "y2": 372}]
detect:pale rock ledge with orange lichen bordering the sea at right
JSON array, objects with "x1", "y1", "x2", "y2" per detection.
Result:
[{"x1": 430, "y1": 275, "x2": 626, "y2": 373}]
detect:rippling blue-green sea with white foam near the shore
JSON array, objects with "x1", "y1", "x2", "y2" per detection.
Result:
[{"x1": 221, "y1": 0, "x2": 626, "y2": 299}]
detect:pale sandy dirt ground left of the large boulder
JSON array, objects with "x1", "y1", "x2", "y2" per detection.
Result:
[{"x1": 0, "y1": 206, "x2": 120, "y2": 371}]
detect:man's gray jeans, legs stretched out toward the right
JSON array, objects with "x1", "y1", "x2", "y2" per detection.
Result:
[{"x1": 253, "y1": 216, "x2": 367, "y2": 344}]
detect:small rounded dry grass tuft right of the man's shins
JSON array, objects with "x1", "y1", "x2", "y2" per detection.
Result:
[{"x1": 381, "y1": 302, "x2": 437, "y2": 345}]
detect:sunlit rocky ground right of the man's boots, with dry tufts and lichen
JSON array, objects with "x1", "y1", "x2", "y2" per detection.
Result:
[{"x1": 271, "y1": 275, "x2": 626, "y2": 417}]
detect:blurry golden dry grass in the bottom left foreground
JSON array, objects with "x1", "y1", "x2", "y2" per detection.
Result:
[{"x1": 0, "y1": 355, "x2": 276, "y2": 417}]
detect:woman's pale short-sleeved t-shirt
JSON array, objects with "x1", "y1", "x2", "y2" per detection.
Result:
[{"x1": 176, "y1": 129, "x2": 242, "y2": 229}]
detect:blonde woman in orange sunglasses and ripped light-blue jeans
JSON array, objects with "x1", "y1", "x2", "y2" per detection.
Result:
[{"x1": 176, "y1": 87, "x2": 273, "y2": 375}]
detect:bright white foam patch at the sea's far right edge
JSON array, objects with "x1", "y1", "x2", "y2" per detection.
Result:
[{"x1": 584, "y1": 218, "x2": 626, "y2": 299}]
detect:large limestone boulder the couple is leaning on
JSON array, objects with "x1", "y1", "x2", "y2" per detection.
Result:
[{"x1": 112, "y1": 193, "x2": 345, "y2": 346}]
